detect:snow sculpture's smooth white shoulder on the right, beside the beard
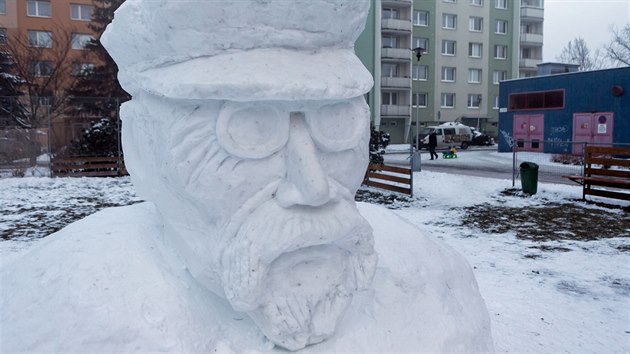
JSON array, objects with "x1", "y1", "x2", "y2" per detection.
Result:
[{"x1": 336, "y1": 203, "x2": 493, "y2": 353}]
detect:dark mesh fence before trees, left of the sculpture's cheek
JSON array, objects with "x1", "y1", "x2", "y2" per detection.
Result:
[{"x1": 0, "y1": 96, "x2": 127, "y2": 177}]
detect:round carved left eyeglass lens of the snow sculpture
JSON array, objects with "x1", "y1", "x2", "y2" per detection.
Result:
[{"x1": 217, "y1": 103, "x2": 289, "y2": 159}]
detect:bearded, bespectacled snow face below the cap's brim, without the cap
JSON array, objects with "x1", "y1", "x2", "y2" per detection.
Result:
[{"x1": 123, "y1": 97, "x2": 376, "y2": 350}]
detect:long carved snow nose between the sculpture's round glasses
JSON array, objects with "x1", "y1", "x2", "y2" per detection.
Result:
[{"x1": 276, "y1": 112, "x2": 331, "y2": 208}]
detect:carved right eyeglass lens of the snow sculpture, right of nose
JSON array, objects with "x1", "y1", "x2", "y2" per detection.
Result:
[{"x1": 307, "y1": 98, "x2": 370, "y2": 151}]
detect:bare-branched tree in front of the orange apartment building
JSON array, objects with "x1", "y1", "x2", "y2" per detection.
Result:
[{"x1": 0, "y1": 23, "x2": 94, "y2": 128}]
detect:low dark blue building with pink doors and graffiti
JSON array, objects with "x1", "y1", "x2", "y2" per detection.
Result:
[{"x1": 498, "y1": 67, "x2": 630, "y2": 155}]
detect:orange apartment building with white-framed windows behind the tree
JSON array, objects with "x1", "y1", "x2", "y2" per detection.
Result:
[{"x1": 0, "y1": 0, "x2": 99, "y2": 94}]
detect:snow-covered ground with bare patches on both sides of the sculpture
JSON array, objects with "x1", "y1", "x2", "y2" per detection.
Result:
[{"x1": 0, "y1": 159, "x2": 630, "y2": 353}]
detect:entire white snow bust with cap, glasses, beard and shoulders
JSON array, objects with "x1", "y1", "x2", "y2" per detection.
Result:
[{"x1": 0, "y1": 0, "x2": 493, "y2": 353}]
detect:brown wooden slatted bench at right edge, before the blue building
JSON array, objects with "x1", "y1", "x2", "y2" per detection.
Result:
[{"x1": 562, "y1": 146, "x2": 630, "y2": 201}]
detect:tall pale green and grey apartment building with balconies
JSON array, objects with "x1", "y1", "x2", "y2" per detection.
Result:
[{"x1": 357, "y1": 0, "x2": 544, "y2": 143}]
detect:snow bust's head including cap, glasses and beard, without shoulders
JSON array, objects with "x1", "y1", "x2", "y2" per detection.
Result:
[{"x1": 103, "y1": 0, "x2": 377, "y2": 350}]
